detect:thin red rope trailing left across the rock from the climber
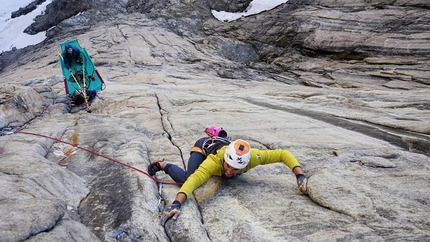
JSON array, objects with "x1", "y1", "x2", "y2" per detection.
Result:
[{"x1": 16, "y1": 106, "x2": 182, "y2": 185}]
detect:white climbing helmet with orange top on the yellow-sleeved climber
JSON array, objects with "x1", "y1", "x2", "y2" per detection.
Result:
[{"x1": 224, "y1": 139, "x2": 251, "y2": 169}]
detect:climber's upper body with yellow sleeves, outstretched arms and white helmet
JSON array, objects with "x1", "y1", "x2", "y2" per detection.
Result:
[{"x1": 161, "y1": 134, "x2": 307, "y2": 226}]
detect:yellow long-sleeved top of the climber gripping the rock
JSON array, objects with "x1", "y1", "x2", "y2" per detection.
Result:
[{"x1": 178, "y1": 146, "x2": 300, "y2": 197}]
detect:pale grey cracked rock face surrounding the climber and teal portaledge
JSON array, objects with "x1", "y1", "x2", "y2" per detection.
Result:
[{"x1": 0, "y1": 0, "x2": 430, "y2": 242}]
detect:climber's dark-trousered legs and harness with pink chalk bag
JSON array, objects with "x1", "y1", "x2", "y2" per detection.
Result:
[{"x1": 148, "y1": 126, "x2": 230, "y2": 183}]
